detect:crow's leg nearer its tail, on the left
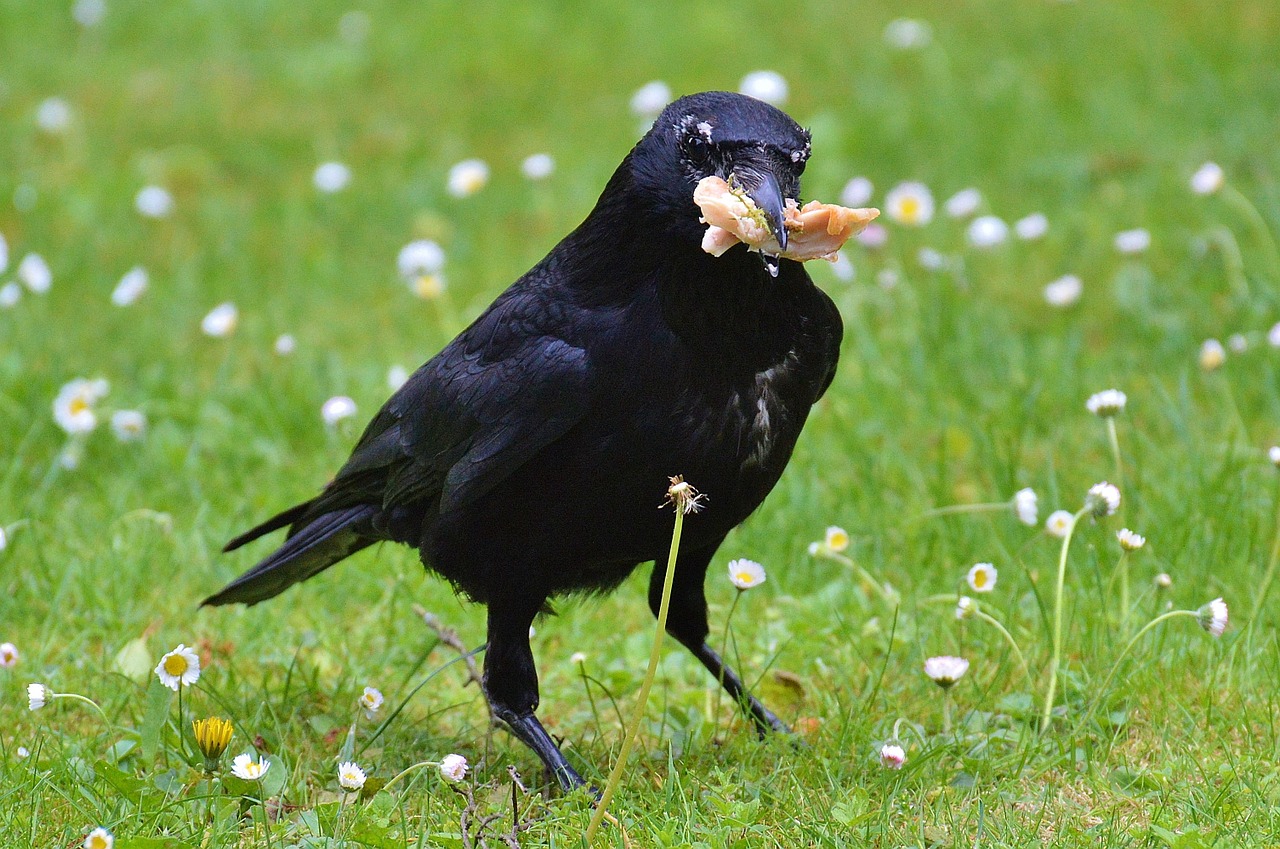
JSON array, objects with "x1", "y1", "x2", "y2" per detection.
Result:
[{"x1": 484, "y1": 598, "x2": 586, "y2": 791}]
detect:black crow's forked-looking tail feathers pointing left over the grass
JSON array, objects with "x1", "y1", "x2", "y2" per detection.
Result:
[{"x1": 201, "y1": 505, "x2": 379, "y2": 606}]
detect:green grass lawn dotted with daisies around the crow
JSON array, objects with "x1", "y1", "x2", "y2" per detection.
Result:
[{"x1": 0, "y1": 0, "x2": 1280, "y2": 848}]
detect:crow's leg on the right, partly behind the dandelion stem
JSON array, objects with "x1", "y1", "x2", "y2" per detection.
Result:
[{"x1": 649, "y1": 544, "x2": 791, "y2": 738}]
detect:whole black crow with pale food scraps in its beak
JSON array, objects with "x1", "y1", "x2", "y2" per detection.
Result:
[{"x1": 205, "y1": 92, "x2": 842, "y2": 789}]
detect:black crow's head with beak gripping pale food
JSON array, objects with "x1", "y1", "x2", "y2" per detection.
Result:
[{"x1": 631, "y1": 91, "x2": 809, "y2": 275}]
